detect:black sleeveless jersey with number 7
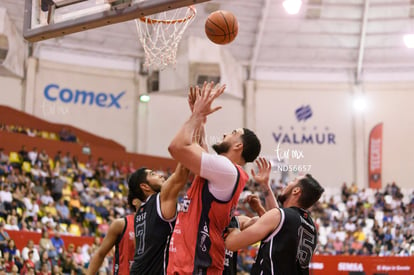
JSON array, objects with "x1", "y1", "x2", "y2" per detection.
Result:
[{"x1": 130, "y1": 193, "x2": 175, "y2": 275}]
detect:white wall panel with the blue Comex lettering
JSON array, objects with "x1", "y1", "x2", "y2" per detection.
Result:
[{"x1": 25, "y1": 59, "x2": 137, "y2": 150}]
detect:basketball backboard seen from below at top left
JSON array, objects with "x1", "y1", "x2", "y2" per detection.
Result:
[{"x1": 23, "y1": 0, "x2": 210, "y2": 42}]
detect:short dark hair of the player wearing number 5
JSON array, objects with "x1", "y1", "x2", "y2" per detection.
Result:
[{"x1": 297, "y1": 174, "x2": 325, "y2": 209}]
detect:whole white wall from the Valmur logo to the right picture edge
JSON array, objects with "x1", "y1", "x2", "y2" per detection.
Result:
[{"x1": 255, "y1": 81, "x2": 414, "y2": 191}]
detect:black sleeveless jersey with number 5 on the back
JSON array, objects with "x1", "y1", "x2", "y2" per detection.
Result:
[{"x1": 251, "y1": 207, "x2": 318, "y2": 275}]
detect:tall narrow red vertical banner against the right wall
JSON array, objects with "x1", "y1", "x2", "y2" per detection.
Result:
[{"x1": 368, "y1": 123, "x2": 383, "y2": 189}]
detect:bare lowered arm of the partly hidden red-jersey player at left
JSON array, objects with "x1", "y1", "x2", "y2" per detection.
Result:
[{"x1": 86, "y1": 218, "x2": 125, "y2": 275}]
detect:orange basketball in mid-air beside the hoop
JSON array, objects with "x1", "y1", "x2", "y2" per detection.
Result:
[{"x1": 205, "y1": 10, "x2": 239, "y2": 45}]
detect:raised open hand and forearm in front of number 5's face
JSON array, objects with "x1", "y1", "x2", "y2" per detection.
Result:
[{"x1": 251, "y1": 157, "x2": 279, "y2": 210}]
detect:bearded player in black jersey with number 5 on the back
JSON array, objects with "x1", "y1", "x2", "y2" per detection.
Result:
[{"x1": 225, "y1": 174, "x2": 324, "y2": 275}]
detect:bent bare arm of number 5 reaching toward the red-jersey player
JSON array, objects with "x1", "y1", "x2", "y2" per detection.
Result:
[{"x1": 225, "y1": 209, "x2": 280, "y2": 251}]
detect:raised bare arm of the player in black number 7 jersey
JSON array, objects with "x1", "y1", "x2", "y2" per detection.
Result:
[{"x1": 160, "y1": 163, "x2": 190, "y2": 220}]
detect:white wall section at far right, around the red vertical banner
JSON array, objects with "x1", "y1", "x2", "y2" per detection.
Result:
[{"x1": 364, "y1": 82, "x2": 414, "y2": 190}]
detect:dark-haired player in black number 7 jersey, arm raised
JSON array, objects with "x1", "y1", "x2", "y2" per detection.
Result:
[{"x1": 128, "y1": 164, "x2": 189, "y2": 275}]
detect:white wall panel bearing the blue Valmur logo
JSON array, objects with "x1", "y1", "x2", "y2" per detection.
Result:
[{"x1": 255, "y1": 81, "x2": 354, "y2": 191}]
